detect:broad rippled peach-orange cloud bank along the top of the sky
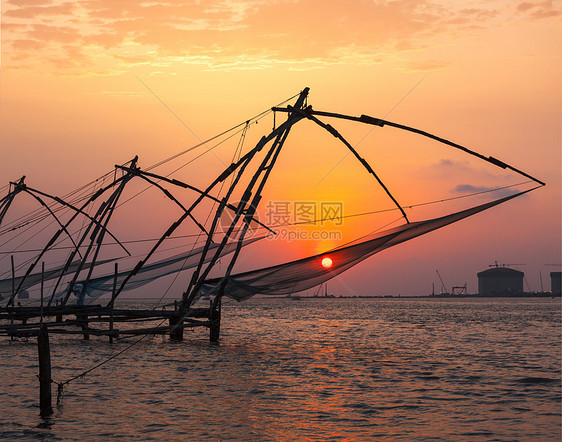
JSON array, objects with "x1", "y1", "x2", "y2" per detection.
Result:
[{"x1": 3, "y1": 0, "x2": 504, "y2": 70}]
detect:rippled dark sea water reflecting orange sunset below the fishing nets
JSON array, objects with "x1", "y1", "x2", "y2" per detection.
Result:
[{"x1": 0, "y1": 298, "x2": 561, "y2": 441}]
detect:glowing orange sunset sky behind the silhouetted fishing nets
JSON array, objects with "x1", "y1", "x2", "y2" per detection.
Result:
[{"x1": 0, "y1": 0, "x2": 562, "y2": 294}]
